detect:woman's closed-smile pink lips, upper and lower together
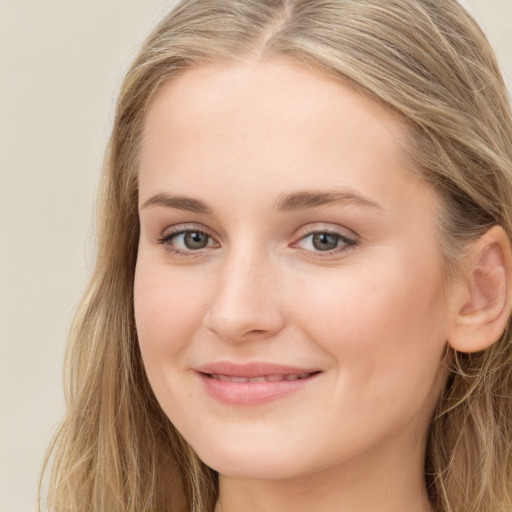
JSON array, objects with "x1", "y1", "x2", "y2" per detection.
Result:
[{"x1": 197, "y1": 362, "x2": 320, "y2": 405}]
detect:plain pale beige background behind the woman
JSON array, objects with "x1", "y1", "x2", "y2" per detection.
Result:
[{"x1": 0, "y1": 0, "x2": 512, "y2": 512}]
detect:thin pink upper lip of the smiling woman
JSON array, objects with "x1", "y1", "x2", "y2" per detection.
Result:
[{"x1": 196, "y1": 361, "x2": 319, "y2": 378}]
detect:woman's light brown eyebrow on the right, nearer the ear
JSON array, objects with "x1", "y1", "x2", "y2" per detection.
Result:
[{"x1": 276, "y1": 190, "x2": 383, "y2": 212}]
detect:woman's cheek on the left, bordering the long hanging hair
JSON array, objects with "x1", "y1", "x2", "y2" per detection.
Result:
[{"x1": 134, "y1": 256, "x2": 215, "y2": 440}]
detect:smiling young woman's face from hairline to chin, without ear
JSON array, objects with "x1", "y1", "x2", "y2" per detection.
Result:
[{"x1": 135, "y1": 59, "x2": 450, "y2": 478}]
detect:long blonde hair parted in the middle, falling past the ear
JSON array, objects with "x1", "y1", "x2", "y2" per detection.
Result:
[{"x1": 42, "y1": 0, "x2": 512, "y2": 512}]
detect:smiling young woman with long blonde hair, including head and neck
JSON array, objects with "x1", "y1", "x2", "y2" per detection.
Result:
[{"x1": 42, "y1": 0, "x2": 512, "y2": 512}]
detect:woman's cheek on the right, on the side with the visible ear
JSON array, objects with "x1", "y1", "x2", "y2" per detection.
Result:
[{"x1": 296, "y1": 255, "x2": 447, "y2": 403}]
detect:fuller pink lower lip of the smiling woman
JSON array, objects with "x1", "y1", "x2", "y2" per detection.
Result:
[{"x1": 199, "y1": 373, "x2": 319, "y2": 405}]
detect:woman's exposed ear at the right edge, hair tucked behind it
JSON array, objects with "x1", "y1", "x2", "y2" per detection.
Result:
[{"x1": 448, "y1": 226, "x2": 512, "y2": 353}]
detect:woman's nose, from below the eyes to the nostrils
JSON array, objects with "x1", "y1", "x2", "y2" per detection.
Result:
[{"x1": 204, "y1": 251, "x2": 284, "y2": 342}]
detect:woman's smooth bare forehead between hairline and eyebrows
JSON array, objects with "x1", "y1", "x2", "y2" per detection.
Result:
[{"x1": 140, "y1": 58, "x2": 428, "y2": 214}]
